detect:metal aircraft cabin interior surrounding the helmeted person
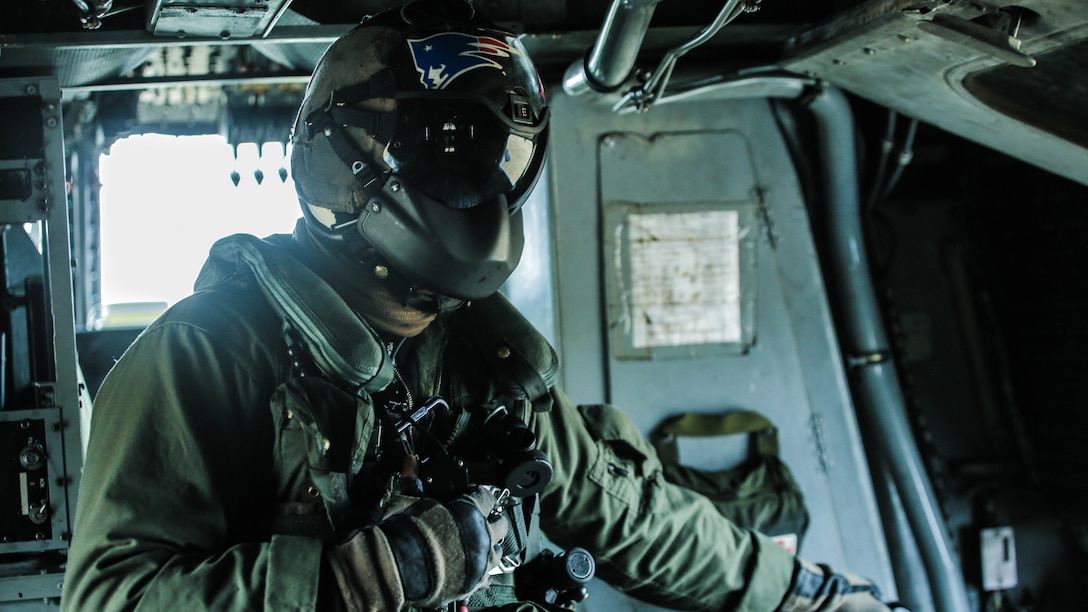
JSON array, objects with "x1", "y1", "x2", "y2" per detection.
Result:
[{"x1": 0, "y1": 0, "x2": 1088, "y2": 612}]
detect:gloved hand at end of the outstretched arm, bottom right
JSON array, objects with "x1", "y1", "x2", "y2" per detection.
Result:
[{"x1": 778, "y1": 559, "x2": 891, "y2": 612}]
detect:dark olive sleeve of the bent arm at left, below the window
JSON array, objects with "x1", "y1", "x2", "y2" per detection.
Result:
[{"x1": 62, "y1": 285, "x2": 321, "y2": 612}]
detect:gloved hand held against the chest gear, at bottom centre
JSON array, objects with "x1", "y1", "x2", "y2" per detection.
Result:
[{"x1": 325, "y1": 488, "x2": 508, "y2": 611}]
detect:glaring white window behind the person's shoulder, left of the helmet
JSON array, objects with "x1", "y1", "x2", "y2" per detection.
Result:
[{"x1": 99, "y1": 134, "x2": 300, "y2": 310}]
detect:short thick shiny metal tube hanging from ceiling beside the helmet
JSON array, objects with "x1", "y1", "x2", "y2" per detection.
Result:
[{"x1": 562, "y1": 0, "x2": 662, "y2": 96}]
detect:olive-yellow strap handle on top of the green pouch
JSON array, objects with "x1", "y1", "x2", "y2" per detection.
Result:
[{"x1": 651, "y1": 411, "x2": 778, "y2": 464}]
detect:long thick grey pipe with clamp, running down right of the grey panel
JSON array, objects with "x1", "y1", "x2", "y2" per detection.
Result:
[{"x1": 808, "y1": 88, "x2": 969, "y2": 612}]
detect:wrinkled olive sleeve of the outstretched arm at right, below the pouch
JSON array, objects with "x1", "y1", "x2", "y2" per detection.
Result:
[{"x1": 534, "y1": 391, "x2": 793, "y2": 612}]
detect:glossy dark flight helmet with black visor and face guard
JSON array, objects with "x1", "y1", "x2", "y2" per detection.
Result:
[{"x1": 292, "y1": 0, "x2": 548, "y2": 299}]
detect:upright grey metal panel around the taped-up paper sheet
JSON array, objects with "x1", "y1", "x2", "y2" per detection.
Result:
[{"x1": 551, "y1": 88, "x2": 894, "y2": 610}]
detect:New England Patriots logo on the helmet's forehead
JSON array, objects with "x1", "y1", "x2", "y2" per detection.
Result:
[{"x1": 408, "y1": 32, "x2": 518, "y2": 89}]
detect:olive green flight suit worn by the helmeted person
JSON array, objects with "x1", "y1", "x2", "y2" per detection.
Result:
[{"x1": 62, "y1": 231, "x2": 794, "y2": 612}]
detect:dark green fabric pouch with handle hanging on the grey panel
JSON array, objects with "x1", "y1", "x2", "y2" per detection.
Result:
[{"x1": 651, "y1": 411, "x2": 808, "y2": 544}]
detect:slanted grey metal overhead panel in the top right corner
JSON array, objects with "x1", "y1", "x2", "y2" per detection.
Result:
[{"x1": 780, "y1": 0, "x2": 1088, "y2": 184}]
